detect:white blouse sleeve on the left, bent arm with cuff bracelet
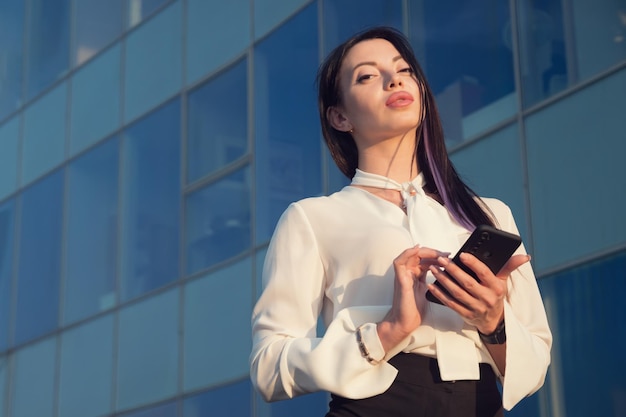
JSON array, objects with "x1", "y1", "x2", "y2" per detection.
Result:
[{"x1": 250, "y1": 203, "x2": 397, "y2": 401}]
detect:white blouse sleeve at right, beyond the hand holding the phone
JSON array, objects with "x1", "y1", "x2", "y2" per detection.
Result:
[{"x1": 488, "y1": 203, "x2": 552, "y2": 410}]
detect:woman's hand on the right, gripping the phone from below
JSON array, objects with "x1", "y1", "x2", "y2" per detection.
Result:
[{"x1": 429, "y1": 253, "x2": 530, "y2": 334}]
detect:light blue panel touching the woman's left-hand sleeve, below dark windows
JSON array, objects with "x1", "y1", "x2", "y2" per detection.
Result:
[{"x1": 184, "y1": 258, "x2": 252, "y2": 391}]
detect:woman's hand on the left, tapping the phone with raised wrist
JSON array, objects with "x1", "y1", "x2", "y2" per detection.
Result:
[{"x1": 377, "y1": 245, "x2": 447, "y2": 352}]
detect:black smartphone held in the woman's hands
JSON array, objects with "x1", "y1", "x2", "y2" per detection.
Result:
[{"x1": 426, "y1": 224, "x2": 522, "y2": 304}]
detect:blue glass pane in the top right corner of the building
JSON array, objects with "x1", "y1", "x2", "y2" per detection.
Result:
[{"x1": 570, "y1": 0, "x2": 626, "y2": 80}]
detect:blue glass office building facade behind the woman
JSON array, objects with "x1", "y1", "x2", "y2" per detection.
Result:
[{"x1": 0, "y1": 0, "x2": 626, "y2": 417}]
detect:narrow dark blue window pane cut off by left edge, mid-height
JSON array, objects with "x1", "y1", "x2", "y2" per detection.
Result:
[{"x1": 0, "y1": 200, "x2": 15, "y2": 352}]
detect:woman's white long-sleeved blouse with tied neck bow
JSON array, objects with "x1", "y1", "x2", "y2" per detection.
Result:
[{"x1": 250, "y1": 170, "x2": 552, "y2": 410}]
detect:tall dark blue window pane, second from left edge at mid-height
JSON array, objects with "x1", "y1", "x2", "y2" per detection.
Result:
[{"x1": 14, "y1": 171, "x2": 63, "y2": 344}]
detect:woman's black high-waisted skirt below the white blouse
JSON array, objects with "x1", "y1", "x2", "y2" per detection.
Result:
[{"x1": 326, "y1": 353, "x2": 504, "y2": 417}]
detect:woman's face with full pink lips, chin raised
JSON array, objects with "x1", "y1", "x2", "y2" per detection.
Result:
[{"x1": 329, "y1": 39, "x2": 422, "y2": 145}]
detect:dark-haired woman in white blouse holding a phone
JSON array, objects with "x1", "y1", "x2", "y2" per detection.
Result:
[{"x1": 250, "y1": 28, "x2": 552, "y2": 417}]
